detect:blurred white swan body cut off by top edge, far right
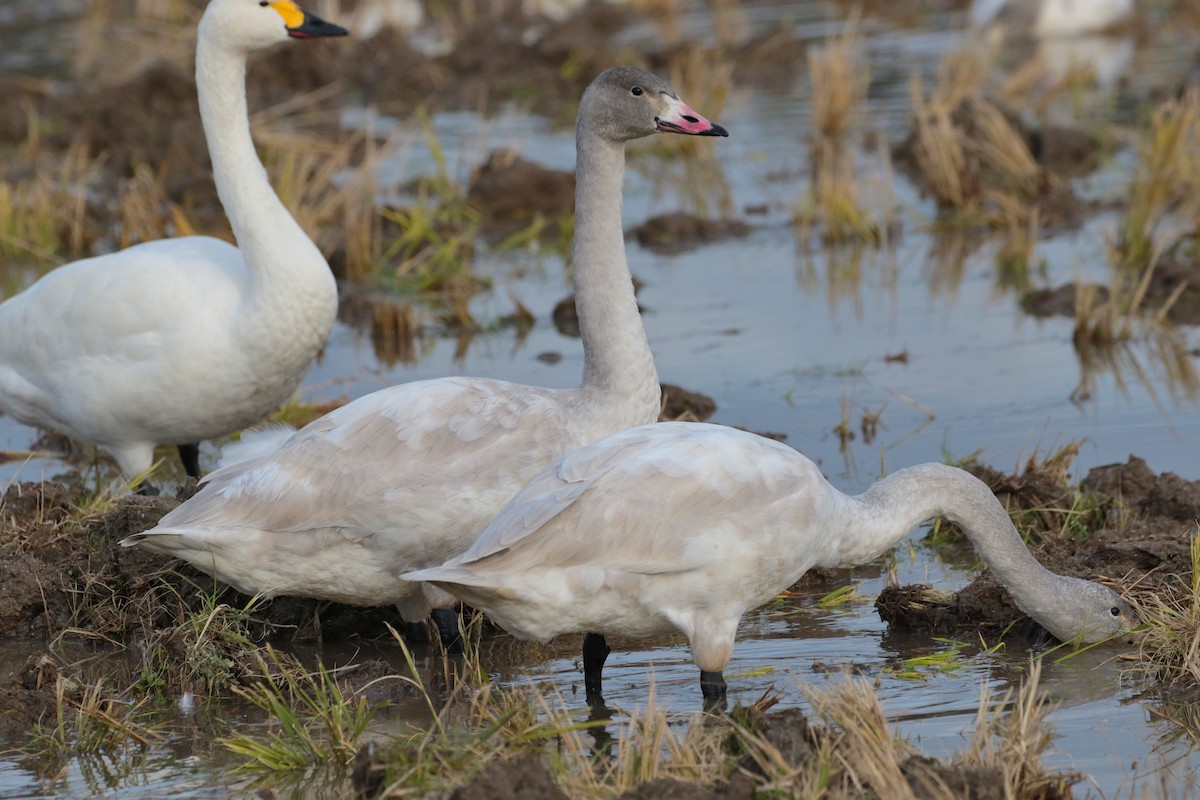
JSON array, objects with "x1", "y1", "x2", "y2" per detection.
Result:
[{"x1": 968, "y1": 0, "x2": 1133, "y2": 37}]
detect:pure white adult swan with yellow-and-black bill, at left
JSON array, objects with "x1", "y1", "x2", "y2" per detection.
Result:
[{"x1": 0, "y1": 0, "x2": 347, "y2": 479}]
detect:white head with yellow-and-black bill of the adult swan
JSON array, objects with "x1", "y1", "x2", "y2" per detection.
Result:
[{"x1": 200, "y1": 0, "x2": 349, "y2": 54}]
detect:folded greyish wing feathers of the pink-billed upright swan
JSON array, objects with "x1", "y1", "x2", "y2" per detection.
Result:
[{"x1": 126, "y1": 379, "x2": 574, "y2": 548}]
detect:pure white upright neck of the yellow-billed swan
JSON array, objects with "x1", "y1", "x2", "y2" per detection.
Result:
[{"x1": 196, "y1": 28, "x2": 336, "y2": 339}]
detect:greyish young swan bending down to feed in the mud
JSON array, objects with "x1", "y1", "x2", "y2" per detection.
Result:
[{"x1": 403, "y1": 422, "x2": 1134, "y2": 704}]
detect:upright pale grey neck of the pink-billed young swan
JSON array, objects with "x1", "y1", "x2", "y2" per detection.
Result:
[{"x1": 571, "y1": 125, "x2": 660, "y2": 419}]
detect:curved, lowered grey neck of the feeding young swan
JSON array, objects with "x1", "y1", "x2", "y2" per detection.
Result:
[{"x1": 839, "y1": 464, "x2": 1076, "y2": 638}]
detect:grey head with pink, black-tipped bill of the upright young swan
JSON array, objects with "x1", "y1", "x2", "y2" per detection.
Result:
[{"x1": 578, "y1": 67, "x2": 728, "y2": 142}]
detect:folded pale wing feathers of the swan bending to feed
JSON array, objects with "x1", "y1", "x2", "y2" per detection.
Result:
[{"x1": 415, "y1": 422, "x2": 824, "y2": 583}]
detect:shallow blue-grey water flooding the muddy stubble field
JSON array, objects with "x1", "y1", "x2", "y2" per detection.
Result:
[{"x1": 0, "y1": 4, "x2": 1200, "y2": 798}]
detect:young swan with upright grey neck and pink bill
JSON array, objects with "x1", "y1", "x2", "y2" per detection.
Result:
[{"x1": 122, "y1": 67, "x2": 727, "y2": 633}]
